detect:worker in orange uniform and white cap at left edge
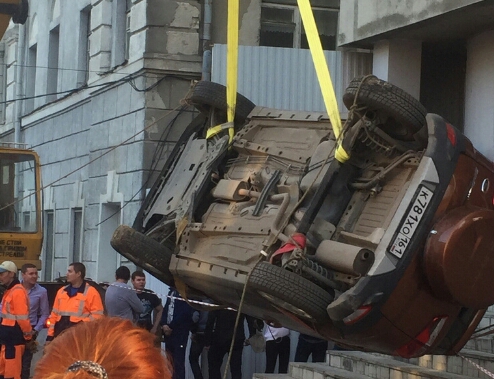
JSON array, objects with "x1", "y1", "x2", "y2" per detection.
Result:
[{"x1": 0, "y1": 261, "x2": 33, "y2": 379}]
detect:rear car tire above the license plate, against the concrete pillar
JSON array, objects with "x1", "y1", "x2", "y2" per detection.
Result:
[{"x1": 343, "y1": 76, "x2": 427, "y2": 141}]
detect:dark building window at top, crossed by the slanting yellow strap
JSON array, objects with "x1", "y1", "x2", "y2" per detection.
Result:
[{"x1": 259, "y1": 3, "x2": 338, "y2": 50}]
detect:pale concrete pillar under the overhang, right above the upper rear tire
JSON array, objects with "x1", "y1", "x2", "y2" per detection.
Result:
[{"x1": 373, "y1": 40, "x2": 422, "y2": 99}]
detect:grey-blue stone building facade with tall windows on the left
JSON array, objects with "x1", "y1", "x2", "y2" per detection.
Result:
[{"x1": 0, "y1": 0, "x2": 201, "y2": 281}]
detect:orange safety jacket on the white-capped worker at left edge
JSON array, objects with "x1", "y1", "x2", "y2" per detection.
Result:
[{"x1": 0, "y1": 280, "x2": 32, "y2": 340}]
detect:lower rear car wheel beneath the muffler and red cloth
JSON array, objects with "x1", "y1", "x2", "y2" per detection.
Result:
[{"x1": 248, "y1": 262, "x2": 334, "y2": 321}]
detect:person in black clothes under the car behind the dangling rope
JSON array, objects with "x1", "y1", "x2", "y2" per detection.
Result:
[{"x1": 204, "y1": 309, "x2": 256, "y2": 379}]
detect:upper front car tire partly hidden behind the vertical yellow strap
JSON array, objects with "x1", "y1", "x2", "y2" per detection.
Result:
[{"x1": 189, "y1": 80, "x2": 256, "y2": 124}]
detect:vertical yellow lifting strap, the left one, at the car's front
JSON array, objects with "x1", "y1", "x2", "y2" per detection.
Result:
[{"x1": 226, "y1": 0, "x2": 239, "y2": 143}]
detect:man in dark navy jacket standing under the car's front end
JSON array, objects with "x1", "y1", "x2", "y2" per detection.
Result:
[{"x1": 160, "y1": 288, "x2": 194, "y2": 379}]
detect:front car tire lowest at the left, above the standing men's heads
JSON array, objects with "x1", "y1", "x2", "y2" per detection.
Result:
[{"x1": 110, "y1": 225, "x2": 173, "y2": 285}]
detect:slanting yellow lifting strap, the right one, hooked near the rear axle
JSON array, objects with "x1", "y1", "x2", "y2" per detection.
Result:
[{"x1": 297, "y1": 0, "x2": 350, "y2": 163}]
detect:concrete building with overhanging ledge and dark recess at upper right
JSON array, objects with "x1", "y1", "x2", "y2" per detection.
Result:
[{"x1": 338, "y1": 0, "x2": 494, "y2": 160}]
